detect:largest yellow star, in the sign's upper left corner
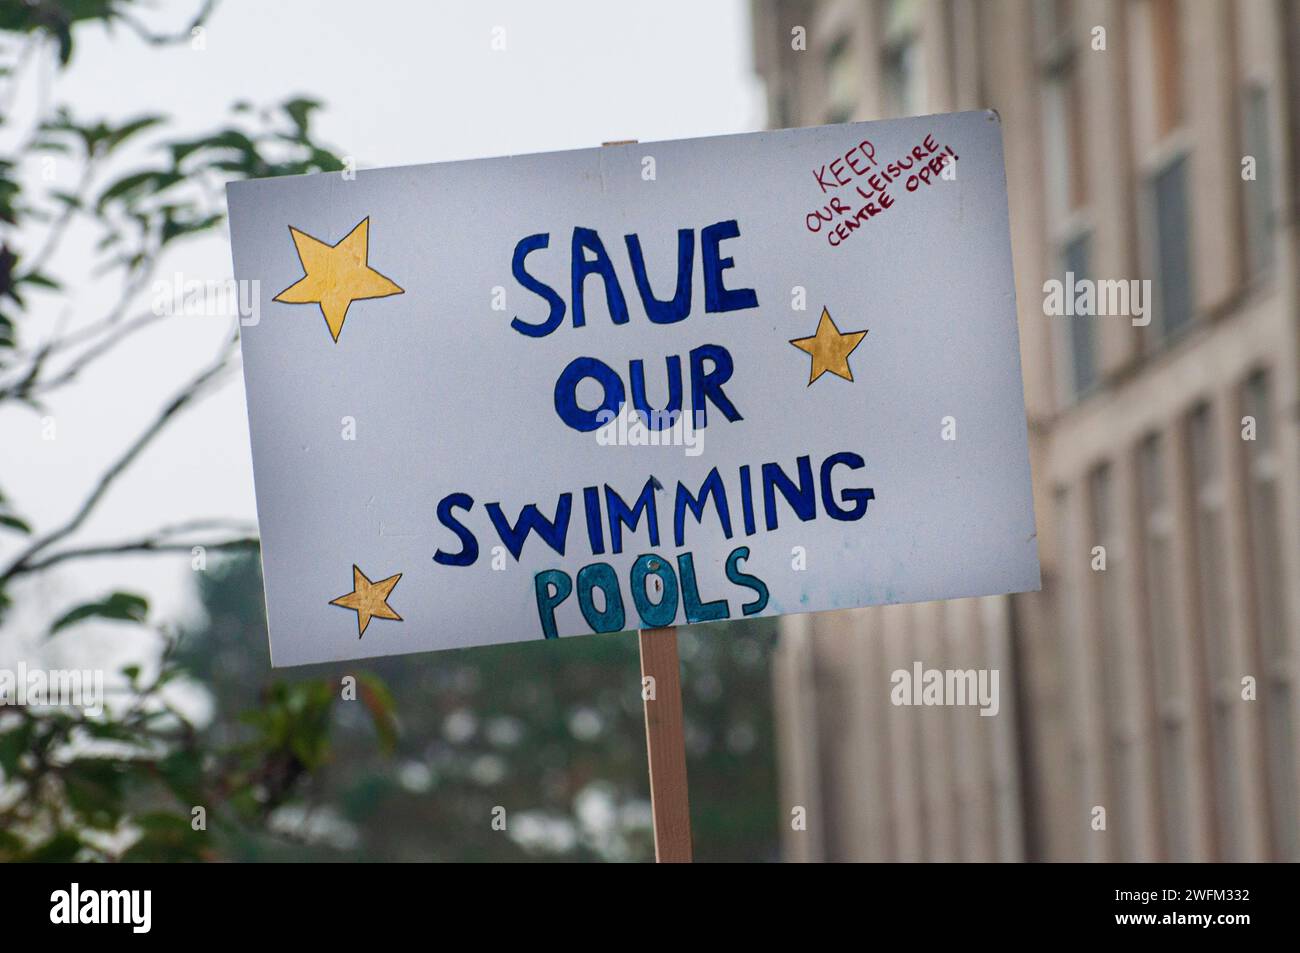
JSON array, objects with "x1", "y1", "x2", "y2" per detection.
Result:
[{"x1": 274, "y1": 217, "x2": 403, "y2": 341}]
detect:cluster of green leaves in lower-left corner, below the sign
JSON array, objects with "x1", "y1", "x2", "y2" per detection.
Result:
[{"x1": 0, "y1": 616, "x2": 393, "y2": 861}]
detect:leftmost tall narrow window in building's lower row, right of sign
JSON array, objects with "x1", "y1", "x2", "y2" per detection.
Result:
[{"x1": 1088, "y1": 464, "x2": 1138, "y2": 861}]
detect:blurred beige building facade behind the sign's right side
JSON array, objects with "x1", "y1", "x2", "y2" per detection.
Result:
[{"x1": 753, "y1": 0, "x2": 1300, "y2": 861}]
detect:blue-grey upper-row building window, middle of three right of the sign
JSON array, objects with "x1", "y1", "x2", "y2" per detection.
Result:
[{"x1": 1149, "y1": 155, "x2": 1195, "y2": 339}]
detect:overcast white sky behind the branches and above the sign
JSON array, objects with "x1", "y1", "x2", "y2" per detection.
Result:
[{"x1": 0, "y1": 0, "x2": 763, "y2": 664}]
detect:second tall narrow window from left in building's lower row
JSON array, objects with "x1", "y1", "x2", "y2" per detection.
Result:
[{"x1": 1138, "y1": 434, "x2": 1192, "y2": 862}]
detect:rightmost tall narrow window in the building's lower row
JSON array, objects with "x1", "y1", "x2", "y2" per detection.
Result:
[{"x1": 1242, "y1": 371, "x2": 1300, "y2": 861}]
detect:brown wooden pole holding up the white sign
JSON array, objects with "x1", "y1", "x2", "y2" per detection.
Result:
[{"x1": 601, "y1": 139, "x2": 690, "y2": 863}]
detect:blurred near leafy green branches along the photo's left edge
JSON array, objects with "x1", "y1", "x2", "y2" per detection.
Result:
[{"x1": 0, "y1": 0, "x2": 397, "y2": 861}]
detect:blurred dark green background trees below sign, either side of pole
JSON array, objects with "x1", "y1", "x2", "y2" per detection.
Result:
[{"x1": 178, "y1": 555, "x2": 780, "y2": 861}]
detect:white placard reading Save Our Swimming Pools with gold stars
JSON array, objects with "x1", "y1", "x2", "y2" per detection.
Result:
[{"x1": 229, "y1": 113, "x2": 1039, "y2": 666}]
